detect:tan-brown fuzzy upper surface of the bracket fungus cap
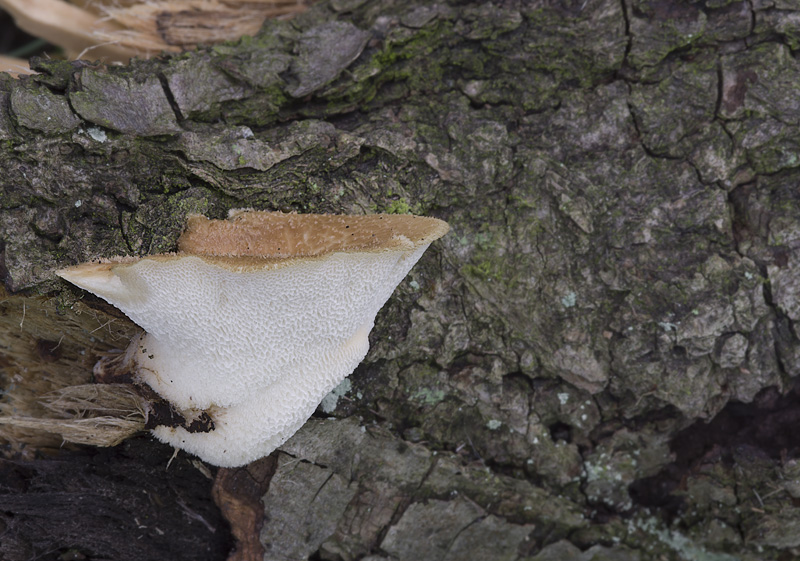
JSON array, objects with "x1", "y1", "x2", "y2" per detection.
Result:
[{"x1": 178, "y1": 211, "x2": 449, "y2": 260}]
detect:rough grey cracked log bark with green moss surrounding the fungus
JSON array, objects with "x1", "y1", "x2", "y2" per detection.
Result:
[{"x1": 0, "y1": 0, "x2": 800, "y2": 561}]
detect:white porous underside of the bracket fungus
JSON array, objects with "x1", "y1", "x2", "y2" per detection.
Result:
[{"x1": 69, "y1": 245, "x2": 427, "y2": 467}]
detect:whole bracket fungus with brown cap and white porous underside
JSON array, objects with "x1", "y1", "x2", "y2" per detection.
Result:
[{"x1": 57, "y1": 211, "x2": 449, "y2": 467}]
